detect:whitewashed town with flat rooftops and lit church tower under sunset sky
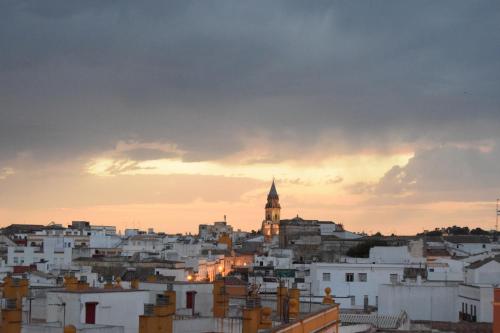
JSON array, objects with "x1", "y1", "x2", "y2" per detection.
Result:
[{"x1": 0, "y1": 181, "x2": 500, "y2": 333}]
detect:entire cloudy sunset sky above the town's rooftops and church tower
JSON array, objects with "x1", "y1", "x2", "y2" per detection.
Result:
[{"x1": 0, "y1": 0, "x2": 500, "y2": 234}]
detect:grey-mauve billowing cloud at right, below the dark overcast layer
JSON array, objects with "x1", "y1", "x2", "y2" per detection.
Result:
[{"x1": 358, "y1": 145, "x2": 500, "y2": 202}]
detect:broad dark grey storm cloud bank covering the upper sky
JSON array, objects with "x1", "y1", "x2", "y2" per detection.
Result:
[{"x1": 0, "y1": 1, "x2": 500, "y2": 163}]
